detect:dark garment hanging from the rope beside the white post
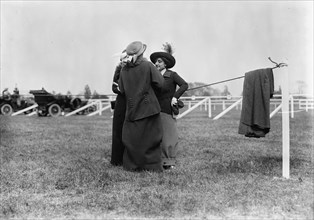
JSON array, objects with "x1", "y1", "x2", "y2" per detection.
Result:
[{"x1": 238, "y1": 68, "x2": 274, "y2": 138}]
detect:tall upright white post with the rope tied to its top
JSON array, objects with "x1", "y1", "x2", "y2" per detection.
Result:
[{"x1": 282, "y1": 67, "x2": 290, "y2": 179}]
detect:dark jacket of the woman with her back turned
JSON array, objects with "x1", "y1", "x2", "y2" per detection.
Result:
[{"x1": 119, "y1": 57, "x2": 164, "y2": 121}]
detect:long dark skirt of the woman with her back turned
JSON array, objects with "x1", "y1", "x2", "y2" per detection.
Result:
[{"x1": 122, "y1": 114, "x2": 163, "y2": 171}]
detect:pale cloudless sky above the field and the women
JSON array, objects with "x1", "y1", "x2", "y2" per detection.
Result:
[{"x1": 0, "y1": 0, "x2": 313, "y2": 96}]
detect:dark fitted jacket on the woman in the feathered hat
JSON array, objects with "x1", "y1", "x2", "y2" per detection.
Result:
[{"x1": 157, "y1": 70, "x2": 189, "y2": 115}]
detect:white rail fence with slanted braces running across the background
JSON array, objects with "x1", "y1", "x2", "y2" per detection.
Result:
[{"x1": 3, "y1": 94, "x2": 314, "y2": 120}]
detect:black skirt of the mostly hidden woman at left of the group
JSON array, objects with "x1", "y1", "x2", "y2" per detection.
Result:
[{"x1": 110, "y1": 95, "x2": 126, "y2": 166}]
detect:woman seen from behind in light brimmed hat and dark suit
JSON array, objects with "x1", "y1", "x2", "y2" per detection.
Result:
[{"x1": 119, "y1": 41, "x2": 164, "y2": 171}]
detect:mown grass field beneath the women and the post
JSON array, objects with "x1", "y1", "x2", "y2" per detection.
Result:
[{"x1": 0, "y1": 108, "x2": 314, "y2": 220}]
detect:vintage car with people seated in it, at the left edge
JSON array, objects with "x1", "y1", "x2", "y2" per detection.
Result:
[{"x1": 0, "y1": 88, "x2": 34, "y2": 115}]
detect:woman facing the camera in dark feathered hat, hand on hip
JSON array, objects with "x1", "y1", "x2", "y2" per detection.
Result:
[{"x1": 150, "y1": 43, "x2": 188, "y2": 169}]
